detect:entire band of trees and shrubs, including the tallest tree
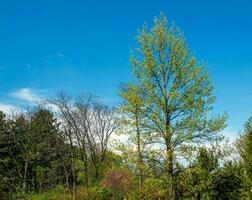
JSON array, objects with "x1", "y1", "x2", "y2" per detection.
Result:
[{"x1": 0, "y1": 15, "x2": 252, "y2": 200}]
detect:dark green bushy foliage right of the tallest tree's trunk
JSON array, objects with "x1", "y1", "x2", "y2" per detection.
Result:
[{"x1": 176, "y1": 148, "x2": 245, "y2": 200}]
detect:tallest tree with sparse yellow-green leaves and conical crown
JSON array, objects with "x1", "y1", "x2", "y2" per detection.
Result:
[{"x1": 122, "y1": 15, "x2": 226, "y2": 200}]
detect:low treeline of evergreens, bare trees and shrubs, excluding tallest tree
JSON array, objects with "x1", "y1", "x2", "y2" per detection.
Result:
[{"x1": 0, "y1": 93, "x2": 252, "y2": 200}]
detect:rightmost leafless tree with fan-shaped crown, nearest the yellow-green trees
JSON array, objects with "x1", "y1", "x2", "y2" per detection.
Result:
[{"x1": 75, "y1": 94, "x2": 118, "y2": 180}]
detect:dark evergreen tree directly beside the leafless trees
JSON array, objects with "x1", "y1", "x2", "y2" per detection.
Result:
[{"x1": 27, "y1": 107, "x2": 59, "y2": 192}]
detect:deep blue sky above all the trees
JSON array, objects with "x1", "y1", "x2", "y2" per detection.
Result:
[{"x1": 0, "y1": 0, "x2": 252, "y2": 140}]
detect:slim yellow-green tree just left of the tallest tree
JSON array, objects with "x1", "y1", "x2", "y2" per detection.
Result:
[{"x1": 118, "y1": 83, "x2": 152, "y2": 190}]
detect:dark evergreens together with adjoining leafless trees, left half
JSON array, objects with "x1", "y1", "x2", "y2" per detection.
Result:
[{"x1": 0, "y1": 93, "x2": 121, "y2": 199}]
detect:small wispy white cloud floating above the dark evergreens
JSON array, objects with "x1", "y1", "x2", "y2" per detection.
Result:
[{"x1": 11, "y1": 88, "x2": 42, "y2": 103}]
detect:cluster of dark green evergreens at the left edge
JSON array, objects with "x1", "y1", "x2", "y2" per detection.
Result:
[{"x1": 0, "y1": 108, "x2": 67, "y2": 198}]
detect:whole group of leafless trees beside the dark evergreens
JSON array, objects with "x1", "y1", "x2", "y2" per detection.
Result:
[{"x1": 48, "y1": 92, "x2": 118, "y2": 189}]
